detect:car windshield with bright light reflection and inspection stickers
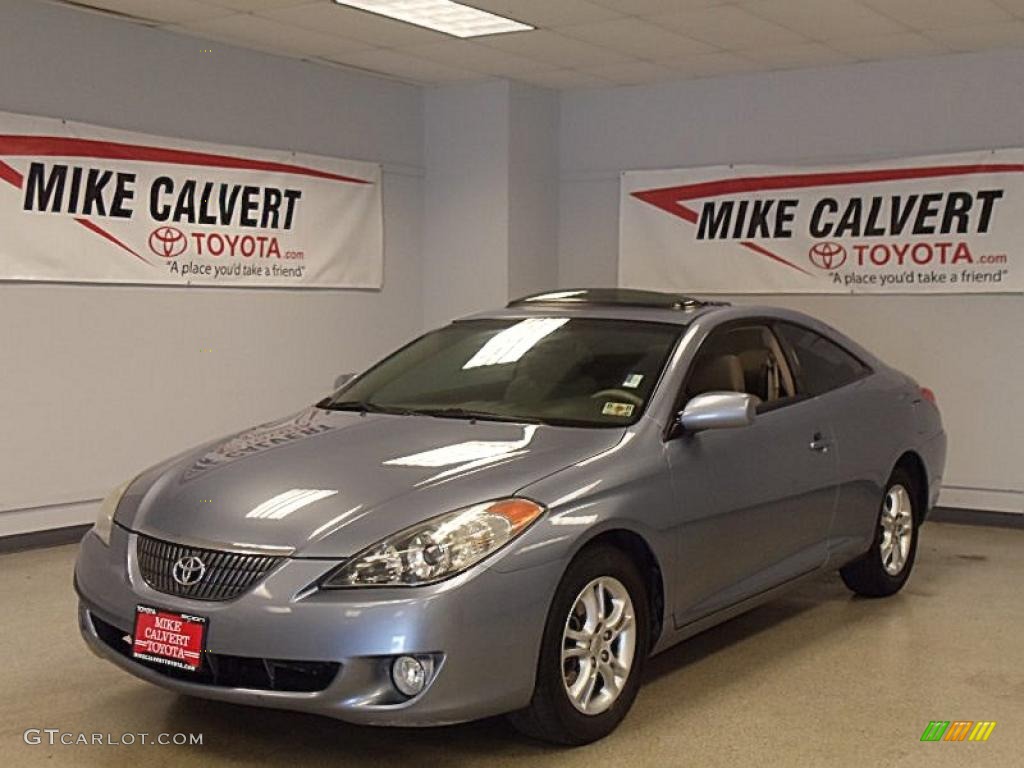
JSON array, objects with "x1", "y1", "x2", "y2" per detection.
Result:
[{"x1": 319, "y1": 316, "x2": 684, "y2": 427}]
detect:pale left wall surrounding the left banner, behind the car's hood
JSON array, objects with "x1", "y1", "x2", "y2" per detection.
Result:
[{"x1": 0, "y1": 0, "x2": 423, "y2": 536}]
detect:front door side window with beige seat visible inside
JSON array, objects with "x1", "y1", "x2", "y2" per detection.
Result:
[{"x1": 684, "y1": 325, "x2": 796, "y2": 406}]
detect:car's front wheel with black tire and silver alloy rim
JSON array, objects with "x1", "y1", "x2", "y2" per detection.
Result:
[{"x1": 509, "y1": 544, "x2": 650, "y2": 745}]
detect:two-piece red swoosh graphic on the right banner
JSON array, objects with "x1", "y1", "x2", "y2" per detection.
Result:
[{"x1": 632, "y1": 163, "x2": 1024, "y2": 274}]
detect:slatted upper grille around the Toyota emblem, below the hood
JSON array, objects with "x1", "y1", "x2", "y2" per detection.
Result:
[{"x1": 138, "y1": 535, "x2": 285, "y2": 600}]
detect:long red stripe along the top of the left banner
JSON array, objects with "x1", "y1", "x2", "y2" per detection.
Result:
[{"x1": 0, "y1": 134, "x2": 373, "y2": 184}]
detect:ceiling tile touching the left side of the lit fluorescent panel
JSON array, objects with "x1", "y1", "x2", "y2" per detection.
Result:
[{"x1": 258, "y1": 0, "x2": 453, "y2": 48}]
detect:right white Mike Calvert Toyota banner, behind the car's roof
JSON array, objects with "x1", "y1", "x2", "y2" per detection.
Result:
[{"x1": 618, "y1": 150, "x2": 1024, "y2": 293}]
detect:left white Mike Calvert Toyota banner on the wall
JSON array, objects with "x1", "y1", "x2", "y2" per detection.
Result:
[{"x1": 0, "y1": 113, "x2": 384, "y2": 288}]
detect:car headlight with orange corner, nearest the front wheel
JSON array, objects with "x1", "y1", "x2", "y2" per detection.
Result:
[{"x1": 323, "y1": 499, "x2": 544, "y2": 588}]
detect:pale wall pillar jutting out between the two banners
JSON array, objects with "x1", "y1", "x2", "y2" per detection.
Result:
[{"x1": 423, "y1": 82, "x2": 558, "y2": 326}]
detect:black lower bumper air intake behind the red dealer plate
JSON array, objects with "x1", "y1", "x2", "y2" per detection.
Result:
[{"x1": 89, "y1": 611, "x2": 341, "y2": 693}]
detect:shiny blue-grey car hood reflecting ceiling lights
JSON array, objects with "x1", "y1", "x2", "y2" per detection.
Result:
[{"x1": 117, "y1": 408, "x2": 624, "y2": 557}]
